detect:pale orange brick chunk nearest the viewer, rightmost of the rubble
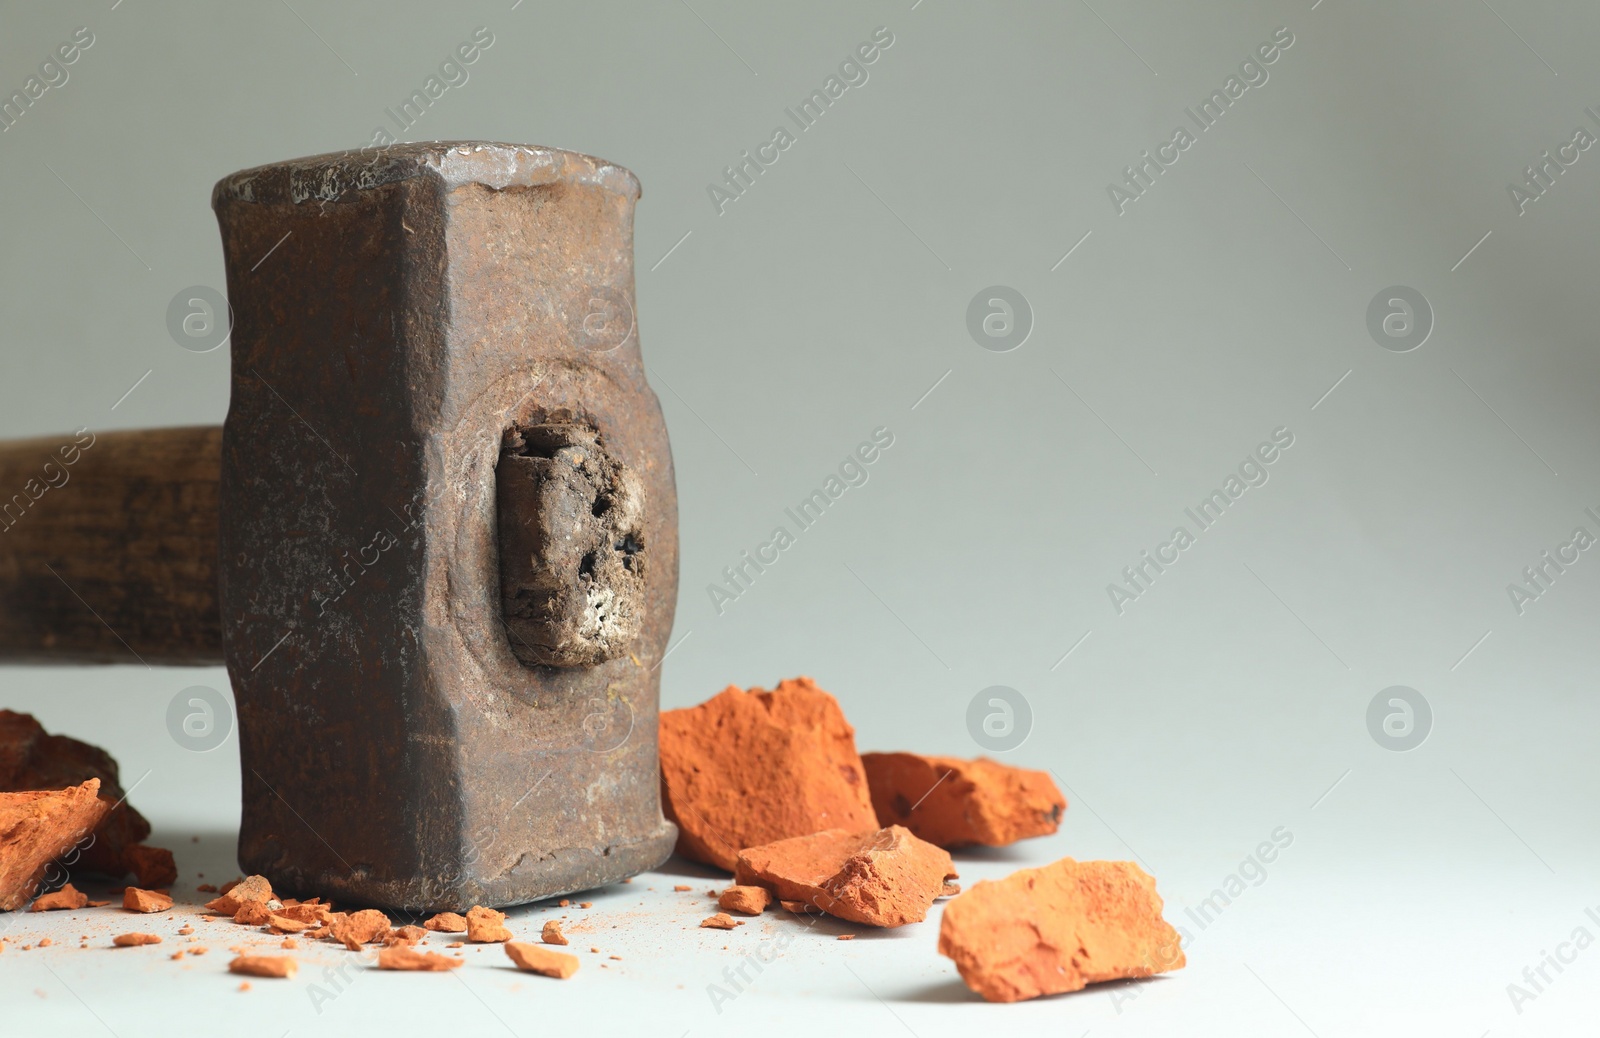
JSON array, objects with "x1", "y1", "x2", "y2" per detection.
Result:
[{"x1": 939, "y1": 857, "x2": 1184, "y2": 1001}]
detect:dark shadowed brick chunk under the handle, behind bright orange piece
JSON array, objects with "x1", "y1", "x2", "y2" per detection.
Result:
[{"x1": 0, "y1": 710, "x2": 167, "y2": 888}]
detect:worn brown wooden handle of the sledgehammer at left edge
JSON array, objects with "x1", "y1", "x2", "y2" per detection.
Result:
[{"x1": 0, "y1": 425, "x2": 222, "y2": 665}]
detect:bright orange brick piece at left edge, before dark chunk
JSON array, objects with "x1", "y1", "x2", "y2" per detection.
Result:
[{"x1": 0, "y1": 777, "x2": 110, "y2": 912}]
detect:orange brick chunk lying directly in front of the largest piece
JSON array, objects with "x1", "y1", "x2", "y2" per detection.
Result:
[{"x1": 734, "y1": 825, "x2": 955, "y2": 926}]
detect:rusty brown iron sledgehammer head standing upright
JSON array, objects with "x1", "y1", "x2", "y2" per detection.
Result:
[{"x1": 213, "y1": 142, "x2": 678, "y2": 910}]
